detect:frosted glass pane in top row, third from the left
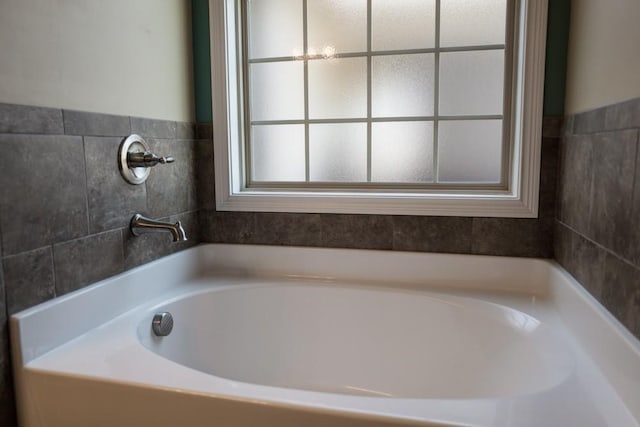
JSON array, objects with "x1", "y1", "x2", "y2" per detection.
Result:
[{"x1": 371, "y1": 0, "x2": 435, "y2": 50}]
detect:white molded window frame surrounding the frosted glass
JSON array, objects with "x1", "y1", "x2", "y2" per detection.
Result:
[{"x1": 209, "y1": 0, "x2": 547, "y2": 218}]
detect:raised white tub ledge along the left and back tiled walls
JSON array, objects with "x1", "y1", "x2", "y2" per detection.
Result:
[{"x1": 9, "y1": 243, "x2": 550, "y2": 364}]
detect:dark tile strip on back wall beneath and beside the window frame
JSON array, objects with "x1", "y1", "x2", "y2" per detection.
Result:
[{"x1": 197, "y1": 117, "x2": 562, "y2": 258}]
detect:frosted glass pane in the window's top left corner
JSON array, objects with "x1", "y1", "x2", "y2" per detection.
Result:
[{"x1": 247, "y1": 0, "x2": 302, "y2": 59}]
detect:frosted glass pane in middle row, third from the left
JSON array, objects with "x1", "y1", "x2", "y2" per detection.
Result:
[{"x1": 371, "y1": 53, "x2": 434, "y2": 117}]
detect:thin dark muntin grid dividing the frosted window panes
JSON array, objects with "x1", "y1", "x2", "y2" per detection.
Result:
[{"x1": 239, "y1": 0, "x2": 517, "y2": 193}]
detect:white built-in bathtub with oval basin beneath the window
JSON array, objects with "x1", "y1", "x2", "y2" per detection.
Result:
[{"x1": 11, "y1": 244, "x2": 640, "y2": 427}]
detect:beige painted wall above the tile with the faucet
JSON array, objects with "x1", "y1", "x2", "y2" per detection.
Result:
[{"x1": 0, "y1": 0, "x2": 195, "y2": 121}]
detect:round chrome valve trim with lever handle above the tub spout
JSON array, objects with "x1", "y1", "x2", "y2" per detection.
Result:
[{"x1": 118, "y1": 134, "x2": 175, "y2": 184}]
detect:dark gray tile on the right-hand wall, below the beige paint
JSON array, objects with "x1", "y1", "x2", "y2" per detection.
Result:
[{"x1": 554, "y1": 98, "x2": 640, "y2": 338}]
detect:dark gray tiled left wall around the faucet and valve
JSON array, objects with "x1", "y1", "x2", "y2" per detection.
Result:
[{"x1": 0, "y1": 104, "x2": 202, "y2": 426}]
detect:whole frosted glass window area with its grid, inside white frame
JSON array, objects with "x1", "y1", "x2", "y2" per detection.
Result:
[{"x1": 238, "y1": 0, "x2": 518, "y2": 191}]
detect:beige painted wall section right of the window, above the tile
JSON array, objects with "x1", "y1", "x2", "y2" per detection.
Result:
[{"x1": 565, "y1": 0, "x2": 640, "y2": 114}]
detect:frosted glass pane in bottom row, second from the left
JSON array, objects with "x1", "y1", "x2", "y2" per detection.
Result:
[{"x1": 309, "y1": 123, "x2": 367, "y2": 182}]
